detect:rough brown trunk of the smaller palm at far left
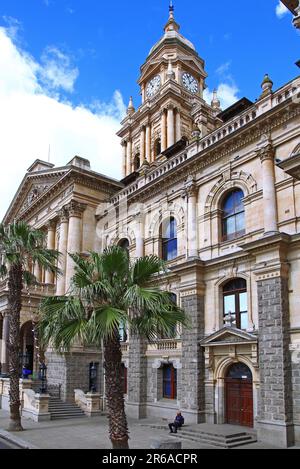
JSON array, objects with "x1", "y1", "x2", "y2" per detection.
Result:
[{"x1": 8, "y1": 264, "x2": 23, "y2": 432}]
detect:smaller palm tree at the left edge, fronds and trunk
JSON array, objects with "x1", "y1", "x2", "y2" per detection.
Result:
[{"x1": 0, "y1": 221, "x2": 59, "y2": 431}]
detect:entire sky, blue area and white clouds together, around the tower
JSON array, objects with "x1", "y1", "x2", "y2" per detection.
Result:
[{"x1": 0, "y1": 0, "x2": 300, "y2": 217}]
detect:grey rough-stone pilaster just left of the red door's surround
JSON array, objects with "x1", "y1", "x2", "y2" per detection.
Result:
[{"x1": 172, "y1": 260, "x2": 205, "y2": 424}]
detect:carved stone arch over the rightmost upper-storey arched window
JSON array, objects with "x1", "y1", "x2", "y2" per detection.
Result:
[{"x1": 205, "y1": 170, "x2": 257, "y2": 213}]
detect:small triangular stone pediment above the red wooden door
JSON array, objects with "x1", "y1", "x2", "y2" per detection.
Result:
[{"x1": 201, "y1": 326, "x2": 258, "y2": 347}]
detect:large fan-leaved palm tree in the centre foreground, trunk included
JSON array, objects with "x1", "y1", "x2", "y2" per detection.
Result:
[{"x1": 39, "y1": 246, "x2": 187, "y2": 449}]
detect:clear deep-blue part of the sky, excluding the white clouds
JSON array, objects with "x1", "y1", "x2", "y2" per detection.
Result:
[{"x1": 0, "y1": 0, "x2": 299, "y2": 103}]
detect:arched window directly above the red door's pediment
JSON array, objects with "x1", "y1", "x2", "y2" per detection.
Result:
[{"x1": 223, "y1": 278, "x2": 248, "y2": 330}]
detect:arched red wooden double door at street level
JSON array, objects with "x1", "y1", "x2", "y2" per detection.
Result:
[{"x1": 225, "y1": 363, "x2": 254, "y2": 427}]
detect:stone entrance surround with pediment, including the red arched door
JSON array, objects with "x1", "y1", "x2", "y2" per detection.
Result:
[{"x1": 201, "y1": 326, "x2": 259, "y2": 428}]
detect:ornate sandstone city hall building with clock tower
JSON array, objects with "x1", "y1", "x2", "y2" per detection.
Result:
[{"x1": 0, "y1": 7, "x2": 300, "y2": 447}]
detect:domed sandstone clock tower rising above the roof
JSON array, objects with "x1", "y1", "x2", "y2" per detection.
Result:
[{"x1": 118, "y1": 2, "x2": 221, "y2": 178}]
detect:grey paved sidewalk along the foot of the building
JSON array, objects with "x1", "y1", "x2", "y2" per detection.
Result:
[{"x1": 0, "y1": 410, "x2": 286, "y2": 450}]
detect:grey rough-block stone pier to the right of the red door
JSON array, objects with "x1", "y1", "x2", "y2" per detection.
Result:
[{"x1": 258, "y1": 277, "x2": 294, "y2": 447}]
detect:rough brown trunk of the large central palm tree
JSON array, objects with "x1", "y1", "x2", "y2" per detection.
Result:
[{"x1": 104, "y1": 333, "x2": 129, "y2": 449}]
